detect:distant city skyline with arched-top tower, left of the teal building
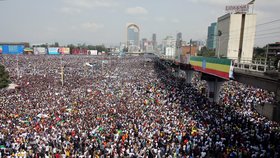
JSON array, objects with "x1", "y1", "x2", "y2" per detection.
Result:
[{"x1": 126, "y1": 23, "x2": 205, "y2": 62}]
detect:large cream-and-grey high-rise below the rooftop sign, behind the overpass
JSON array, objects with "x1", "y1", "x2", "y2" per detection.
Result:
[{"x1": 216, "y1": 13, "x2": 256, "y2": 60}]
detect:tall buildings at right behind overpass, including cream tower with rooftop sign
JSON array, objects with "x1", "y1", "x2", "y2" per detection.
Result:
[{"x1": 206, "y1": 1, "x2": 280, "y2": 62}]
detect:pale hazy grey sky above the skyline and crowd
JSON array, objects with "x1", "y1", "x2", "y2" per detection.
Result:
[{"x1": 0, "y1": 0, "x2": 280, "y2": 46}]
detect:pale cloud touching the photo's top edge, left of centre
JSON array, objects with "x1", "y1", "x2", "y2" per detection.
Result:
[{"x1": 63, "y1": 0, "x2": 117, "y2": 8}]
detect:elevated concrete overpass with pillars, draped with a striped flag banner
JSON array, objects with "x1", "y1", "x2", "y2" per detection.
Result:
[{"x1": 153, "y1": 55, "x2": 280, "y2": 121}]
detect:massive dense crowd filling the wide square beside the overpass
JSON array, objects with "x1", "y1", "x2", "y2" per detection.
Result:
[{"x1": 0, "y1": 56, "x2": 280, "y2": 158}]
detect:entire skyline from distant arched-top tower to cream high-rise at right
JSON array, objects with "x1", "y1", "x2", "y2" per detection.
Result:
[{"x1": 124, "y1": 2, "x2": 280, "y2": 63}]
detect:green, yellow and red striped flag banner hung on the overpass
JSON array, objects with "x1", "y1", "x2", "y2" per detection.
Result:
[{"x1": 190, "y1": 56, "x2": 233, "y2": 80}]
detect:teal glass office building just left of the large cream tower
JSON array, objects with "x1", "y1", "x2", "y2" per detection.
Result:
[{"x1": 206, "y1": 22, "x2": 218, "y2": 50}]
